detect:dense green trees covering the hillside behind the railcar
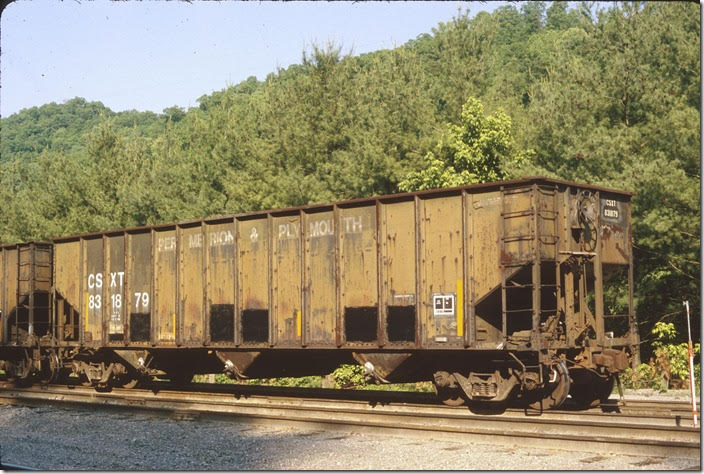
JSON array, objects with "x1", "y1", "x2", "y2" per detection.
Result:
[{"x1": 0, "y1": 2, "x2": 701, "y2": 348}]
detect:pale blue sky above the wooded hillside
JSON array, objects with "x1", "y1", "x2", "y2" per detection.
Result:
[{"x1": 0, "y1": 0, "x2": 508, "y2": 117}]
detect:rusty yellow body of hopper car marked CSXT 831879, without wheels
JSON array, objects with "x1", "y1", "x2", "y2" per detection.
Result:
[{"x1": 2, "y1": 178, "x2": 636, "y2": 362}]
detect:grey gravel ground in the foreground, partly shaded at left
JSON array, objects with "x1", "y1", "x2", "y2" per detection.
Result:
[{"x1": 0, "y1": 394, "x2": 700, "y2": 471}]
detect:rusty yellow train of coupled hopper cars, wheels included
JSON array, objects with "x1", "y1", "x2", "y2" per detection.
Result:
[{"x1": 0, "y1": 178, "x2": 638, "y2": 408}]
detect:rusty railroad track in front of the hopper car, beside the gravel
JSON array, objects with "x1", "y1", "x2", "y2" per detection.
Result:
[{"x1": 0, "y1": 384, "x2": 700, "y2": 459}]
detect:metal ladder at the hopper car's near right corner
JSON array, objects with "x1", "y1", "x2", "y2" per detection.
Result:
[{"x1": 500, "y1": 184, "x2": 561, "y2": 349}]
